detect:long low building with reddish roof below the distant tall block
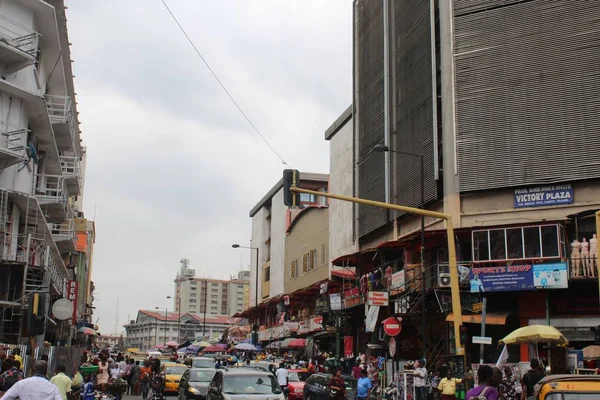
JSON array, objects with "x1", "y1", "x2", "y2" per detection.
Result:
[{"x1": 124, "y1": 310, "x2": 239, "y2": 350}]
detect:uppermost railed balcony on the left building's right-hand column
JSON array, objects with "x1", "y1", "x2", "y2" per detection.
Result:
[{"x1": 46, "y1": 94, "x2": 78, "y2": 151}]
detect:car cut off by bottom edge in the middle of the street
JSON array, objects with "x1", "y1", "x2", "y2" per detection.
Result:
[{"x1": 207, "y1": 368, "x2": 285, "y2": 400}]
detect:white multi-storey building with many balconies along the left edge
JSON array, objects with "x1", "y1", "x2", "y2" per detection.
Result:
[{"x1": 0, "y1": 0, "x2": 83, "y2": 343}]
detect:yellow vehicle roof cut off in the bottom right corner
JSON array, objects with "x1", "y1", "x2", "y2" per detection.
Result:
[{"x1": 528, "y1": 375, "x2": 600, "y2": 400}]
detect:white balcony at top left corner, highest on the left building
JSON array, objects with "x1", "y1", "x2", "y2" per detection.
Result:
[{"x1": 0, "y1": 14, "x2": 40, "y2": 73}]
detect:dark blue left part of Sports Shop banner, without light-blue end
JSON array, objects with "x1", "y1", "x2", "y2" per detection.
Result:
[{"x1": 469, "y1": 264, "x2": 535, "y2": 293}]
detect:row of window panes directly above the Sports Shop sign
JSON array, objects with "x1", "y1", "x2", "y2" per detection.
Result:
[{"x1": 472, "y1": 225, "x2": 560, "y2": 261}]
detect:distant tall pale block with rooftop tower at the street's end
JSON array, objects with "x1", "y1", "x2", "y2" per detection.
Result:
[{"x1": 174, "y1": 258, "x2": 249, "y2": 316}]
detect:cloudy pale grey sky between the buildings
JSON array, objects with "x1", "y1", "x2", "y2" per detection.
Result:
[{"x1": 67, "y1": 0, "x2": 352, "y2": 333}]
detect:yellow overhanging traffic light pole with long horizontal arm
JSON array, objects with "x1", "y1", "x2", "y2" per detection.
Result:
[{"x1": 290, "y1": 186, "x2": 464, "y2": 355}]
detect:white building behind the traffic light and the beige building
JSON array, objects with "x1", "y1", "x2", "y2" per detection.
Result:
[{"x1": 249, "y1": 172, "x2": 329, "y2": 307}]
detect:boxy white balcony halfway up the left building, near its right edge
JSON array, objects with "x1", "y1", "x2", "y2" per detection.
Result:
[{"x1": 35, "y1": 174, "x2": 69, "y2": 222}]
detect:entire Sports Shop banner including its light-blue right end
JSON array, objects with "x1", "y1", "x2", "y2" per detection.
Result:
[{"x1": 469, "y1": 263, "x2": 569, "y2": 293}]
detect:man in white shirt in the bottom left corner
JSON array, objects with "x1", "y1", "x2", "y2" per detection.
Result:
[{"x1": 2, "y1": 360, "x2": 62, "y2": 400}]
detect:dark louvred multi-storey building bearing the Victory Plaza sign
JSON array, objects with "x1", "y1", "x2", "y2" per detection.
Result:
[{"x1": 330, "y1": 0, "x2": 600, "y2": 365}]
